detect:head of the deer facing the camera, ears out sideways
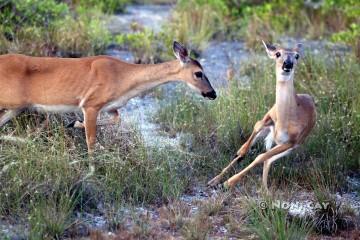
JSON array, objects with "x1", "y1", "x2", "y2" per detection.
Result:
[{"x1": 263, "y1": 41, "x2": 302, "y2": 81}]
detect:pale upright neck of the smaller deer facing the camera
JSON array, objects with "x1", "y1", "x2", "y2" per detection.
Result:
[{"x1": 276, "y1": 74, "x2": 297, "y2": 128}]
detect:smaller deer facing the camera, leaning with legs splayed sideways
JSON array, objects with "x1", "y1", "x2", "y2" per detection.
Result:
[{"x1": 208, "y1": 42, "x2": 316, "y2": 191}]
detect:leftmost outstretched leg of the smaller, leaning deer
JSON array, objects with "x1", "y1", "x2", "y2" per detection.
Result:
[{"x1": 208, "y1": 113, "x2": 272, "y2": 187}]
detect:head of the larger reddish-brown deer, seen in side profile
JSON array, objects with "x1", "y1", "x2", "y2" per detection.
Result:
[{"x1": 173, "y1": 41, "x2": 216, "y2": 100}]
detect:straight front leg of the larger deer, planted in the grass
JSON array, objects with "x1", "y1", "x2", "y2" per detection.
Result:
[{"x1": 83, "y1": 107, "x2": 99, "y2": 153}]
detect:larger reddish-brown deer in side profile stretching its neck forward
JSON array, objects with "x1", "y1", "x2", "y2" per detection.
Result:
[{"x1": 0, "y1": 42, "x2": 216, "y2": 152}]
